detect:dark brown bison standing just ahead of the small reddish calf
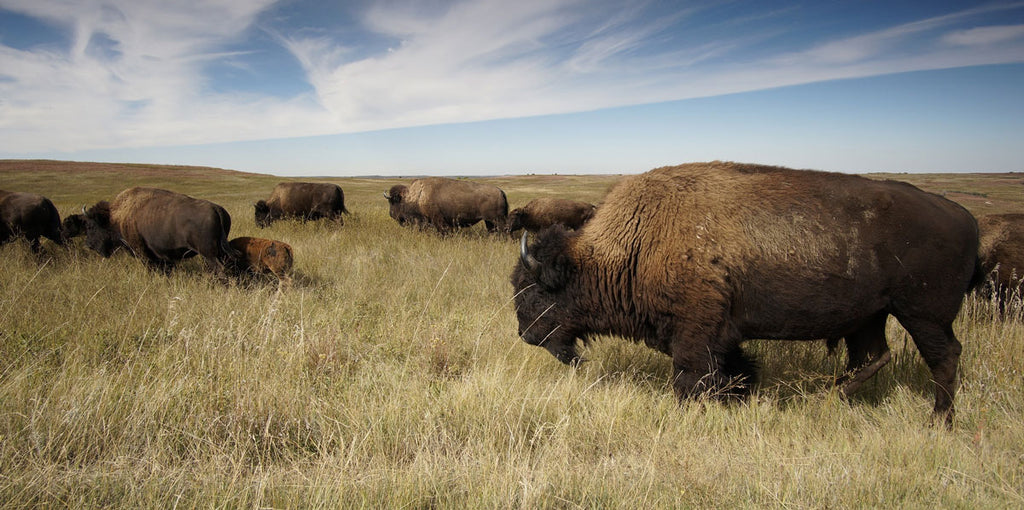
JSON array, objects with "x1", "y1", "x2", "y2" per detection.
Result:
[{"x1": 75, "y1": 187, "x2": 238, "y2": 278}]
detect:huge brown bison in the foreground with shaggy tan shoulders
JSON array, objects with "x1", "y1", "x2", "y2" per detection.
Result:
[{"x1": 511, "y1": 162, "x2": 978, "y2": 423}]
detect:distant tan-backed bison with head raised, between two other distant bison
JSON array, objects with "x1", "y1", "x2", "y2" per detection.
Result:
[{"x1": 384, "y1": 177, "x2": 509, "y2": 233}]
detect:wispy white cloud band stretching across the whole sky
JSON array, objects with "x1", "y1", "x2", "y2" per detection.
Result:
[{"x1": 0, "y1": 0, "x2": 1024, "y2": 153}]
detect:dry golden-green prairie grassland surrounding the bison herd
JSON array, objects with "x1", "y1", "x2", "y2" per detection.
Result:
[{"x1": 0, "y1": 162, "x2": 1024, "y2": 509}]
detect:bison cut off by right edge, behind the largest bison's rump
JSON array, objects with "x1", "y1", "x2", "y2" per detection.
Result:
[{"x1": 978, "y1": 214, "x2": 1024, "y2": 315}]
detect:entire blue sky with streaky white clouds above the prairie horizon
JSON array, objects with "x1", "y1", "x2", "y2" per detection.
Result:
[{"x1": 0, "y1": 0, "x2": 1024, "y2": 176}]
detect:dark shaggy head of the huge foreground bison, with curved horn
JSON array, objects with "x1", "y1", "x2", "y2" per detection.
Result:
[{"x1": 511, "y1": 226, "x2": 584, "y2": 365}]
